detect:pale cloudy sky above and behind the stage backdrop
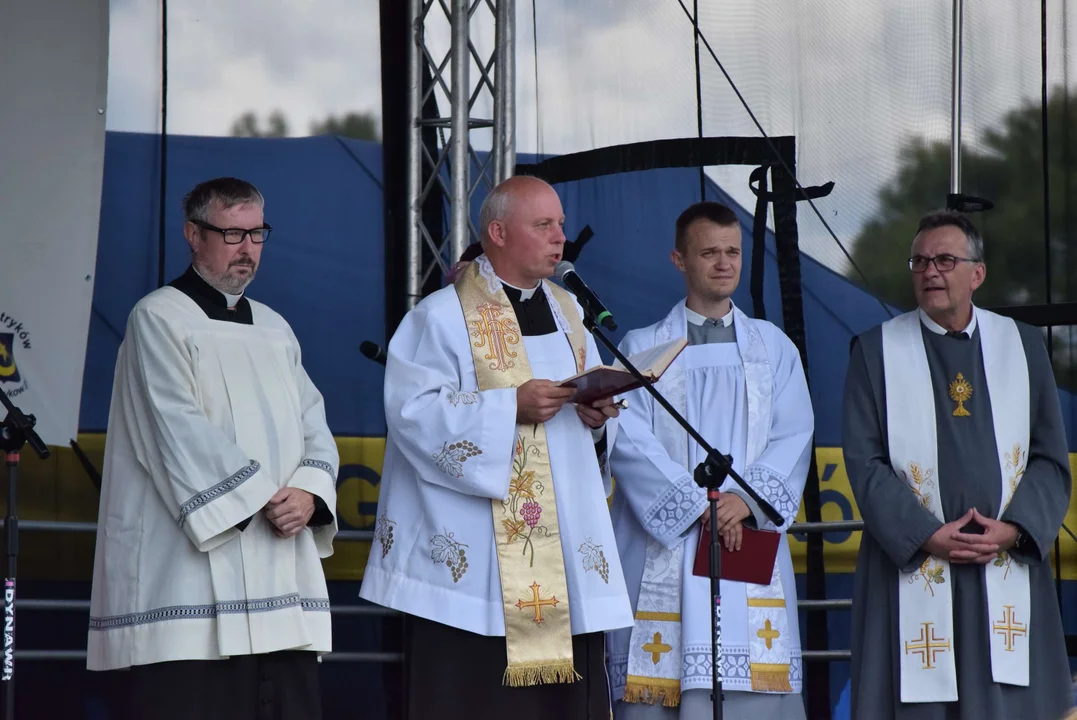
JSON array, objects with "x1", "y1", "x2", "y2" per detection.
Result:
[{"x1": 107, "y1": 0, "x2": 1077, "y2": 270}]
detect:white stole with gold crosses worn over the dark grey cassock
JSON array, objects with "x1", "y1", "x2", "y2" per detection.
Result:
[{"x1": 882, "y1": 308, "x2": 1032, "y2": 703}]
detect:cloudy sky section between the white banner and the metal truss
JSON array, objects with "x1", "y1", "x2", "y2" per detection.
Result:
[{"x1": 108, "y1": 0, "x2": 381, "y2": 136}]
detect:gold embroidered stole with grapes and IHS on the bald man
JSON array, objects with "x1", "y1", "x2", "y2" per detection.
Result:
[{"x1": 456, "y1": 257, "x2": 587, "y2": 687}]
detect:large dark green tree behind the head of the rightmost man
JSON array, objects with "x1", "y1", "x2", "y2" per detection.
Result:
[{"x1": 848, "y1": 89, "x2": 1077, "y2": 308}]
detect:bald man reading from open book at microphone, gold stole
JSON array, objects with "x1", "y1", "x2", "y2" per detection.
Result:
[{"x1": 360, "y1": 177, "x2": 632, "y2": 720}]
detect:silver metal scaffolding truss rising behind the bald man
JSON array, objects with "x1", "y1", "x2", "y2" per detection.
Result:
[{"x1": 407, "y1": 0, "x2": 516, "y2": 310}]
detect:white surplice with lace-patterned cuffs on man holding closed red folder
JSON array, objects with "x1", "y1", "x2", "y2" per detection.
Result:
[{"x1": 609, "y1": 300, "x2": 814, "y2": 700}]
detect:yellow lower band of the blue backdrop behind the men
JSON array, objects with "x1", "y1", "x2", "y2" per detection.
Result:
[{"x1": 6, "y1": 434, "x2": 1077, "y2": 580}]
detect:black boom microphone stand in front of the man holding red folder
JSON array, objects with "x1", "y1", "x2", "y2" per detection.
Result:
[{"x1": 584, "y1": 316, "x2": 785, "y2": 720}]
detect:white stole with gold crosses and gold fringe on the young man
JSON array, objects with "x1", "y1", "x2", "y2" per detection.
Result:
[{"x1": 624, "y1": 303, "x2": 793, "y2": 707}]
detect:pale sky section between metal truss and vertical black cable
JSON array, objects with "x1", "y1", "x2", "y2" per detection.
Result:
[{"x1": 516, "y1": 0, "x2": 696, "y2": 153}]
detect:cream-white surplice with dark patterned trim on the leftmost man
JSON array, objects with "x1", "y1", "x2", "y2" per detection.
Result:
[{"x1": 87, "y1": 287, "x2": 339, "y2": 670}]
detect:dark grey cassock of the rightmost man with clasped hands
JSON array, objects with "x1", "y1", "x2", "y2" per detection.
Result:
[{"x1": 842, "y1": 323, "x2": 1073, "y2": 720}]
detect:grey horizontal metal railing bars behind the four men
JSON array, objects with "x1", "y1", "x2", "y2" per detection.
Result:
[{"x1": 0, "y1": 519, "x2": 864, "y2": 663}]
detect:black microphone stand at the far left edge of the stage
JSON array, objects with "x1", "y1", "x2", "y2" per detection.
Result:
[{"x1": 0, "y1": 390, "x2": 50, "y2": 720}]
